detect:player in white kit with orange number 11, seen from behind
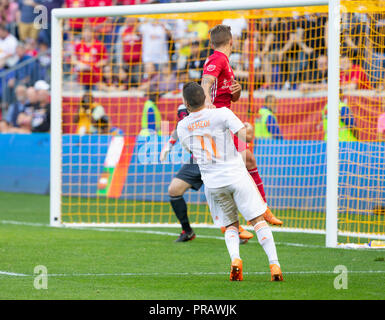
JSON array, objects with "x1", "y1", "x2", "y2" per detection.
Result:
[{"x1": 177, "y1": 82, "x2": 283, "y2": 281}]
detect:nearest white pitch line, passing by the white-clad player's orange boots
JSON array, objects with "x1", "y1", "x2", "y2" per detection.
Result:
[{"x1": 0, "y1": 270, "x2": 385, "y2": 278}]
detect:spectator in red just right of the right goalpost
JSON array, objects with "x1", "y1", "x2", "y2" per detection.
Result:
[{"x1": 340, "y1": 53, "x2": 371, "y2": 90}]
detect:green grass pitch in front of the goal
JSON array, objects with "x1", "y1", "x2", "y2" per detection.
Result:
[{"x1": 0, "y1": 193, "x2": 385, "y2": 300}]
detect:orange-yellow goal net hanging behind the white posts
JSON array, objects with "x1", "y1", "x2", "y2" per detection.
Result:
[{"x1": 51, "y1": 1, "x2": 385, "y2": 248}]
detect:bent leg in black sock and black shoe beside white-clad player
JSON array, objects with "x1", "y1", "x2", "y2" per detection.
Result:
[{"x1": 168, "y1": 178, "x2": 195, "y2": 242}]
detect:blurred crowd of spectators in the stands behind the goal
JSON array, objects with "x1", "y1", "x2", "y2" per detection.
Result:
[{"x1": 0, "y1": 0, "x2": 385, "y2": 133}]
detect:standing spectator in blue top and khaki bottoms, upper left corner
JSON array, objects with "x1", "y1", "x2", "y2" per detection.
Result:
[{"x1": 18, "y1": 0, "x2": 40, "y2": 41}]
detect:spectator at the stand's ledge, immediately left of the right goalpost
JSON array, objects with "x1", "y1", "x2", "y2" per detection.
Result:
[{"x1": 299, "y1": 55, "x2": 328, "y2": 92}]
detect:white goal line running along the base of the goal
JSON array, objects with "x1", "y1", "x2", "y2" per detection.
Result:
[{"x1": 0, "y1": 220, "x2": 385, "y2": 251}]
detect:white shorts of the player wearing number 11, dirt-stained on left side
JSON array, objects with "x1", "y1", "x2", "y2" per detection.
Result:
[{"x1": 205, "y1": 172, "x2": 267, "y2": 227}]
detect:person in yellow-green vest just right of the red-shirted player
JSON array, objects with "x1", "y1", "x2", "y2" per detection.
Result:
[{"x1": 255, "y1": 95, "x2": 283, "y2": 139}]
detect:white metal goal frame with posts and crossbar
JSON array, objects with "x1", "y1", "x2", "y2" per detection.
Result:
[{"x1": 50, "y1": 0, "x2": 340, "y2": 247}]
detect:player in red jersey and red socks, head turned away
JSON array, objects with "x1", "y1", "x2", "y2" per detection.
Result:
[{"x1": 201, "y1": 25, "x2": 283, "y2": 225}]
